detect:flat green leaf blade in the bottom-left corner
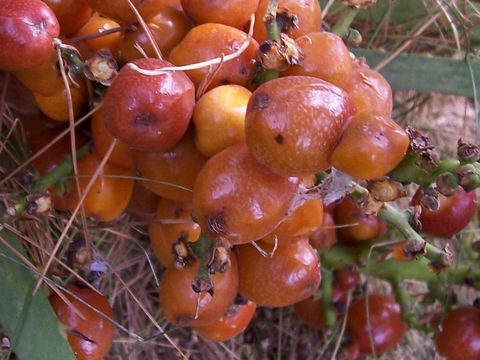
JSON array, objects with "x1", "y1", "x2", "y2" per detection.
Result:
[{"x1": 0, "y1": 230, "x2": 75, "y2": 360}]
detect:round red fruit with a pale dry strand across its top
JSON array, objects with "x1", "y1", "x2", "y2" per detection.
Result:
[{"x1": 103, "y1": 59, "x2": 195, "y2": 151}]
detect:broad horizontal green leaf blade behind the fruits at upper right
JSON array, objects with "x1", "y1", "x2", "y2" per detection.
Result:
[{"x1": 351, "y1": 49, "x2": 480, "y2": 98}]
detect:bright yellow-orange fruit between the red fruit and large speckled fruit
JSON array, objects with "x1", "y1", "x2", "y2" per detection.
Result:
[{"x1": 192, "y1": 85, "x2": 252, "y2": 157}]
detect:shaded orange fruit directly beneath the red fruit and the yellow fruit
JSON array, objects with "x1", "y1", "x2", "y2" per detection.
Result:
[{"x1": 133, "y1": 132, "x2": 207, "y2": 201}]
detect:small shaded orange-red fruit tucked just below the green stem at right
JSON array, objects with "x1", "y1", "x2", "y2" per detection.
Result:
[{"x1": 334, "y1": 198, "x2": 383, "y2": 244}]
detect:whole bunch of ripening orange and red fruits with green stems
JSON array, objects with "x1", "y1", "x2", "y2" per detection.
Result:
[{"x1": 0, "y1": 0, "x2": 480, "y2": 359}]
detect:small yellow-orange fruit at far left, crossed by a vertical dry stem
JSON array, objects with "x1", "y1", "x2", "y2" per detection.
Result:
[{"x1": 33, "y1": 80, "x2": 87, "y2": 122}]
